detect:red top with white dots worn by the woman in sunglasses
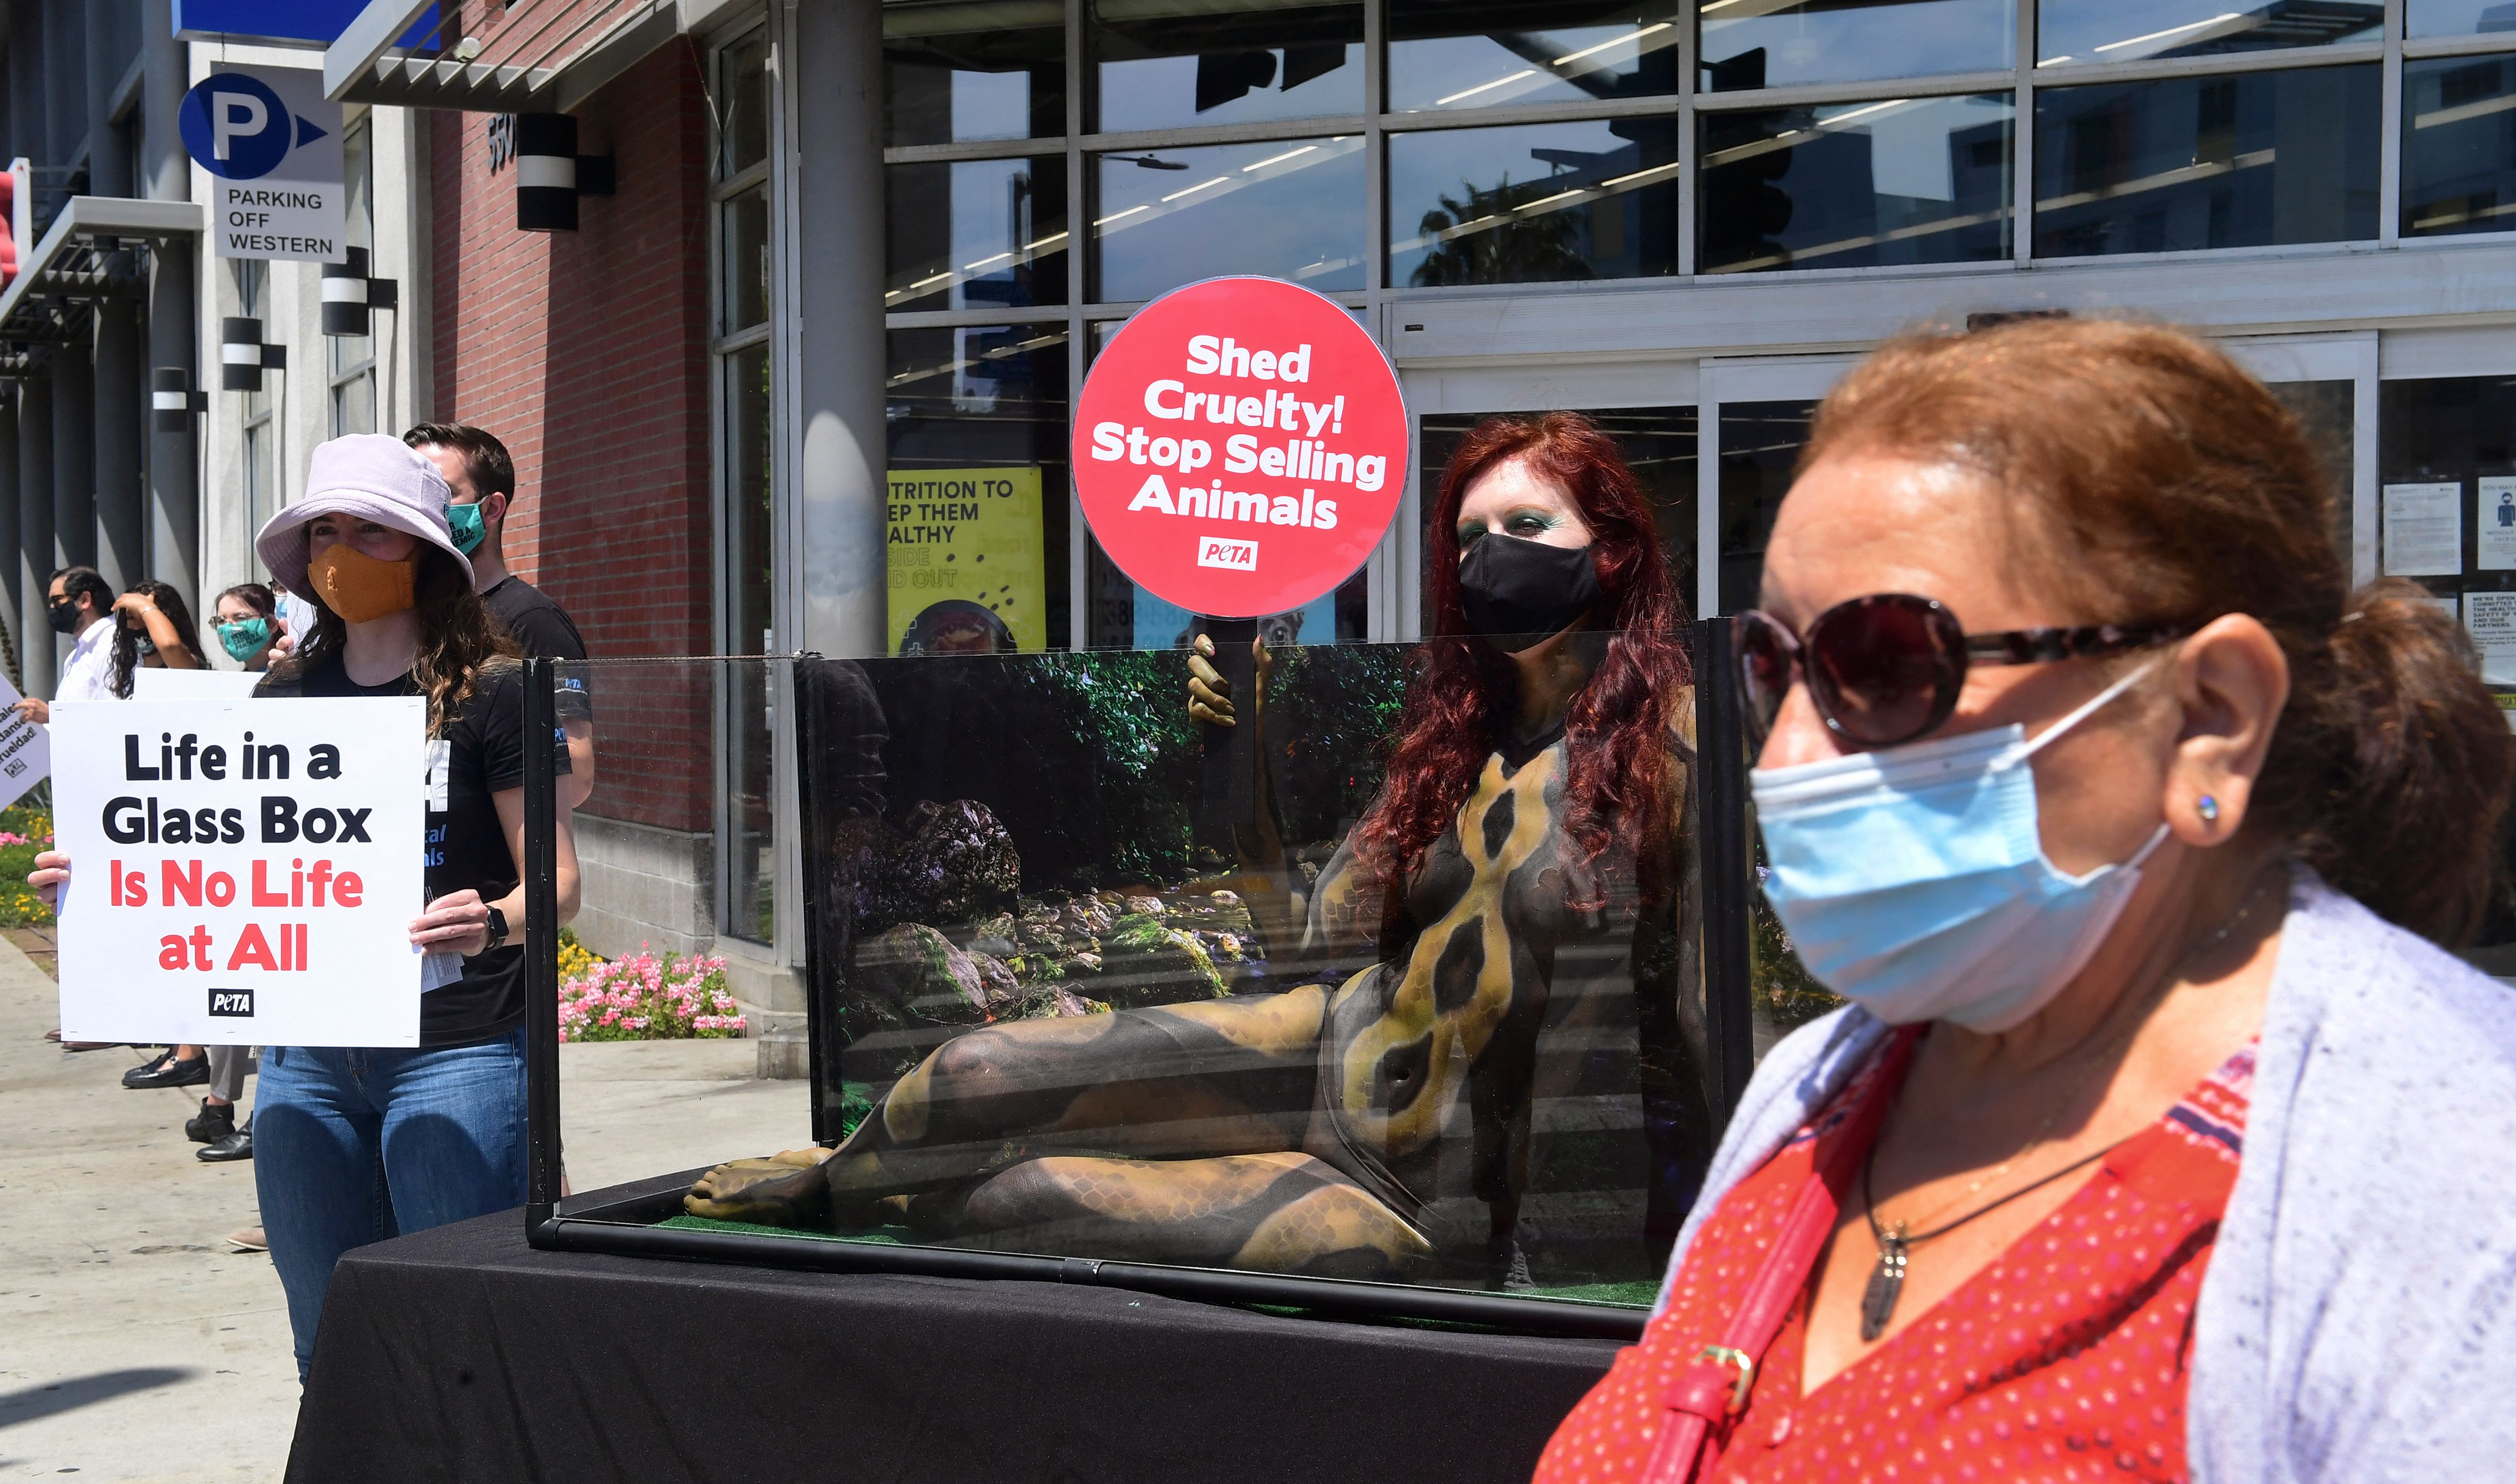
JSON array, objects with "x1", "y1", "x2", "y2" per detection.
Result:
[{"x1": 1537, "y1": 1046, "x2": 2254, "y2": 1484}]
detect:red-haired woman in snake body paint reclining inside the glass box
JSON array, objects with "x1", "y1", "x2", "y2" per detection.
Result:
[{"x1": 687, "y1": 415, "x2": 1708, "y2": 1285}]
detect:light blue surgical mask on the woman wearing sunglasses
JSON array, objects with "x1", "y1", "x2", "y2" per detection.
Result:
[{"x1": 1751, "y1": 667, "x2": 2166, "y2": 1031}]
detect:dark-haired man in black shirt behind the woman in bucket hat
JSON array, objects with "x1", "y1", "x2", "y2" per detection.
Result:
[{"x1": 403, "y1": 423, "x2": 594, "y2": 810}]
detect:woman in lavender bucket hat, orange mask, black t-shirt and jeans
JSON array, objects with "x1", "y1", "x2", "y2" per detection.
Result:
[{"x1": 30, "y1": 432, "x2": 576, "y2": 1376}]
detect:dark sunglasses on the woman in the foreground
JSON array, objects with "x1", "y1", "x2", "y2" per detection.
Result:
[{"x1": 1731, "y1": 593, "x2": 2186, "y2": 747}]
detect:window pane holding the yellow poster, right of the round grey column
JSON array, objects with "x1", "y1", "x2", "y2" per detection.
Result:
[{"x1": 883, "y1": 324, "x2": 1072, "y2": 654}]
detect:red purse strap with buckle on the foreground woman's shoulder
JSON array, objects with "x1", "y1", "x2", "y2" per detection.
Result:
[{"x1": 1641, "y1": 1026, "x2": 1922, "y2": 1484}]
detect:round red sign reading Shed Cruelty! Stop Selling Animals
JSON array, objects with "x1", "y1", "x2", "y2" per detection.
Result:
[{"x1": 1075, "y1": 279, "x2": 1406, "y2": 619}]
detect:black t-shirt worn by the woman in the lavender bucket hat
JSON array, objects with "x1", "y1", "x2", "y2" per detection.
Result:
[{"x1": 254, "y1": 654, "x2": 569, "y2": 1046}]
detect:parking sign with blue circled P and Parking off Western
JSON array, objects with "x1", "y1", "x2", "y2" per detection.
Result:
[{"x1": 176, "y1": 66, "x2": 350, "y2": 262}]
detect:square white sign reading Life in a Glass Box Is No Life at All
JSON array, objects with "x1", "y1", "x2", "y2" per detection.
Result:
[{"x1": 53, "y1": 697, "x2": 428, "y2": 1046}]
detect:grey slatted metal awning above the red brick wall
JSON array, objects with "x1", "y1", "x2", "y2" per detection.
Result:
[{"x1": 322, "y1": 0, "x2": 719, "y2": 113}]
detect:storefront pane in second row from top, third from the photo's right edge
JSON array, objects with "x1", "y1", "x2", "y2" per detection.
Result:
[{"x1": 1701, "y1": 93, "x2": 2013, "y2": 272}]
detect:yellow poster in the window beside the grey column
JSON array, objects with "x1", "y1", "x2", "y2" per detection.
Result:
[{"x1": 886, "y1": 465, "x2": 1049, "y2": 654}]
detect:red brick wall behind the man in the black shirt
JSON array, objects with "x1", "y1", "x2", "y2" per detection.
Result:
[{"x1": 430, "y1": 40, "x2": 714, "y2": 830}]
